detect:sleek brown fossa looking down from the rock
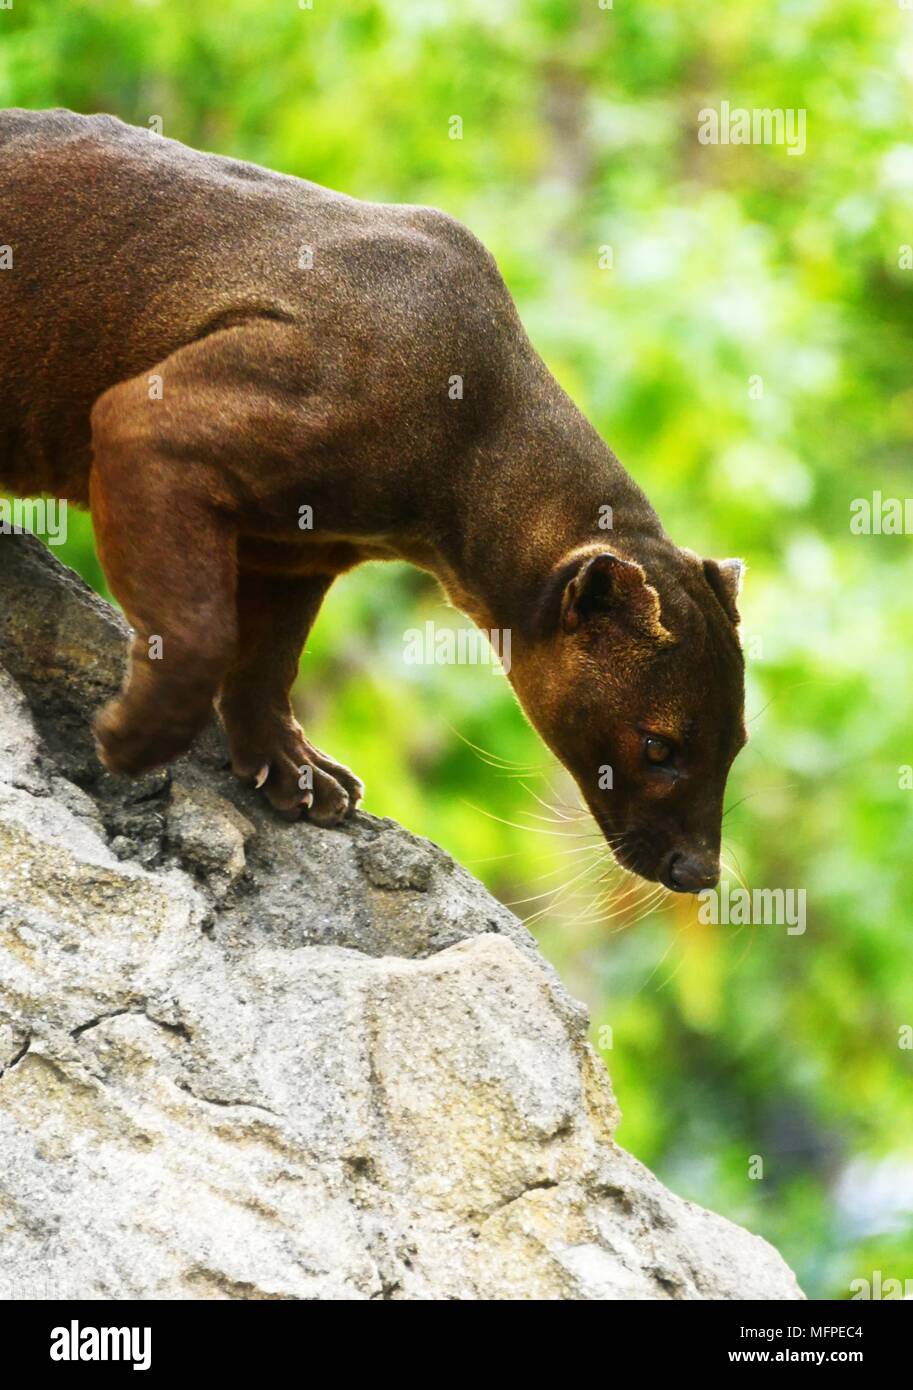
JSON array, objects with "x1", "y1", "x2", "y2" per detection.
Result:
[{"x1": 0, "y1": 111, "x2": 743, "y2": 888}]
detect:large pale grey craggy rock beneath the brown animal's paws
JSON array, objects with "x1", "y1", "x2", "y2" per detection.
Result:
[{"x1": 0, "y1": 535, "x2": 802, "y2": 1300}]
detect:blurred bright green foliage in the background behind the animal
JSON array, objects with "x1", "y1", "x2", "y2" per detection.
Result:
[{"x1": 0, "y1": 0, "x2": 913, "y2": 1298}]
